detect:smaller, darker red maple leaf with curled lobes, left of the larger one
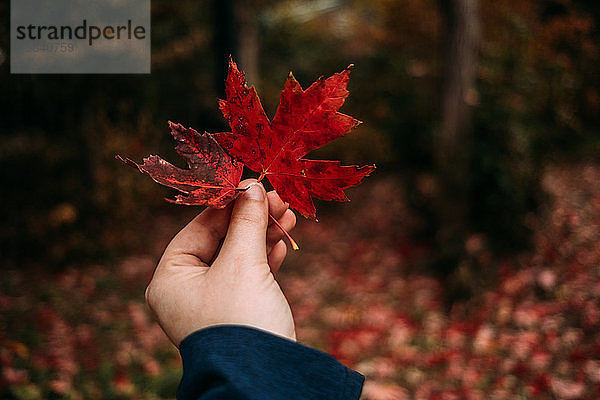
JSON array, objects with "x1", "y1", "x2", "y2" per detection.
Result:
[{"x1": 117, "y1": 122, "x2": 244, "y2": 207}]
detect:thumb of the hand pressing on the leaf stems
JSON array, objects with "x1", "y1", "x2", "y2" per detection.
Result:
[{"x1": 220, "y1": 181, "x2": 269, "y2": 264}]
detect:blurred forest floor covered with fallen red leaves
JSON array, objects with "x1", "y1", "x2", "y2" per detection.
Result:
[{"x1": 0, "y1": 165, "x2": 600, "y2": 400}]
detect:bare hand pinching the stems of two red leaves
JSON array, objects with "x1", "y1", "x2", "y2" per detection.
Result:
[{"x1": 146, "y1": 180, "x2": 296, "y2": 346}]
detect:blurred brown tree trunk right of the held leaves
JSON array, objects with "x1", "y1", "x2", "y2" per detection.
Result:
[{"x1": 435, "y1": 0, "x2": 479, "y2": 276}]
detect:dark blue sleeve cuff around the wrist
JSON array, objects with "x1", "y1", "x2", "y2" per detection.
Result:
[{"x1": 177, "y1": 325, "x2": 364, "y2": 400}]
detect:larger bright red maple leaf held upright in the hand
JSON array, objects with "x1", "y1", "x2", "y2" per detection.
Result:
[{"x1": 215, "y1": 59, "x2": 375, "y2": 219}]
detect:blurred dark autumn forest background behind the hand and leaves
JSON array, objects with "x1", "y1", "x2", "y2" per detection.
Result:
[{"x1": 0, "y1": 0, "x2": 600, "y2": 400}]
